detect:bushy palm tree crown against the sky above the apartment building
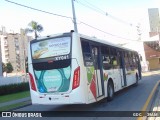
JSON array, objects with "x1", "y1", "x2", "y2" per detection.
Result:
[{"x1": 25, "y1": 21, "x2": 43, "y2": 38}]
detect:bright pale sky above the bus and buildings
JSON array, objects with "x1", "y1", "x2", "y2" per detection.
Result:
[{"x1": 0, "y1": 0, "x2": 160, "y2": 44}]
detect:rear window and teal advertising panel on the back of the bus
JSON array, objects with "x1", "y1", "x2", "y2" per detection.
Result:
[{"x1": 31, "y1": 37, "x2": 71, "y2": 93}]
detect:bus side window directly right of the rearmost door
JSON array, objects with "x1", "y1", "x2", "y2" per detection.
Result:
[{"x1": 101, "y1": 47, "x2": 112, "y2": 70}]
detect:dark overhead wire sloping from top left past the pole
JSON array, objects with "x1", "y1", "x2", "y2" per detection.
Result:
[{"x1": 5, "y1": 0, "x2": 138, "y2": 41}]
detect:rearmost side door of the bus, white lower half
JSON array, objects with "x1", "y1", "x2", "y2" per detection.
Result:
[{"x1": 92, "y1": 46, "x2": 104, "y2": 98}]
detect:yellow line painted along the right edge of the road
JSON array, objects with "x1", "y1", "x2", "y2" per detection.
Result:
[{"x1": 137, "y1": 80, "x2": 160, "y2": 120}]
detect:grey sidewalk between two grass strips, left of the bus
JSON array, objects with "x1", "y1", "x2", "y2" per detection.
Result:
[{"x1": 0, "y1": 97, "x2": 31, "y2": 107}]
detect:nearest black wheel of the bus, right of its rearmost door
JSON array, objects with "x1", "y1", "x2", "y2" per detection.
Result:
[{"x1": 107, "y1": 80, "x2": 114, "y2": 101}]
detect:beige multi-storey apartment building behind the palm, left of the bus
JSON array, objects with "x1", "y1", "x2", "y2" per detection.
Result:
[{"x1": 0, "y1": 29, "x2": 32, "y2": 72}]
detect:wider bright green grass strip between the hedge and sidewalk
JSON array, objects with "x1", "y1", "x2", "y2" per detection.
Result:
[{"x1": 0, "y1": 91, "x2": 30, "y2": 103}]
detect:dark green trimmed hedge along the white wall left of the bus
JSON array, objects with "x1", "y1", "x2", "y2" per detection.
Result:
[{"x1": 0, "y1": 82, "x2": 29, "y2": 96}]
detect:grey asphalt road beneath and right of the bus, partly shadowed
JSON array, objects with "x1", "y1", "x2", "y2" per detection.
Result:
[{"x1": 8, "y1": 74, "x2": 160, "y2": 120}]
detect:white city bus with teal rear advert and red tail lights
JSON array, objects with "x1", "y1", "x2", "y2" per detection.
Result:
[{"x1": 28, "y1": 31, "x2": 141, "y2": 105}]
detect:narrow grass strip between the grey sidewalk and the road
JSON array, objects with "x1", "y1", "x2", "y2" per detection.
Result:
[{"x1": 0, "y1": 101, "x2": 30, "y2": 111}]
